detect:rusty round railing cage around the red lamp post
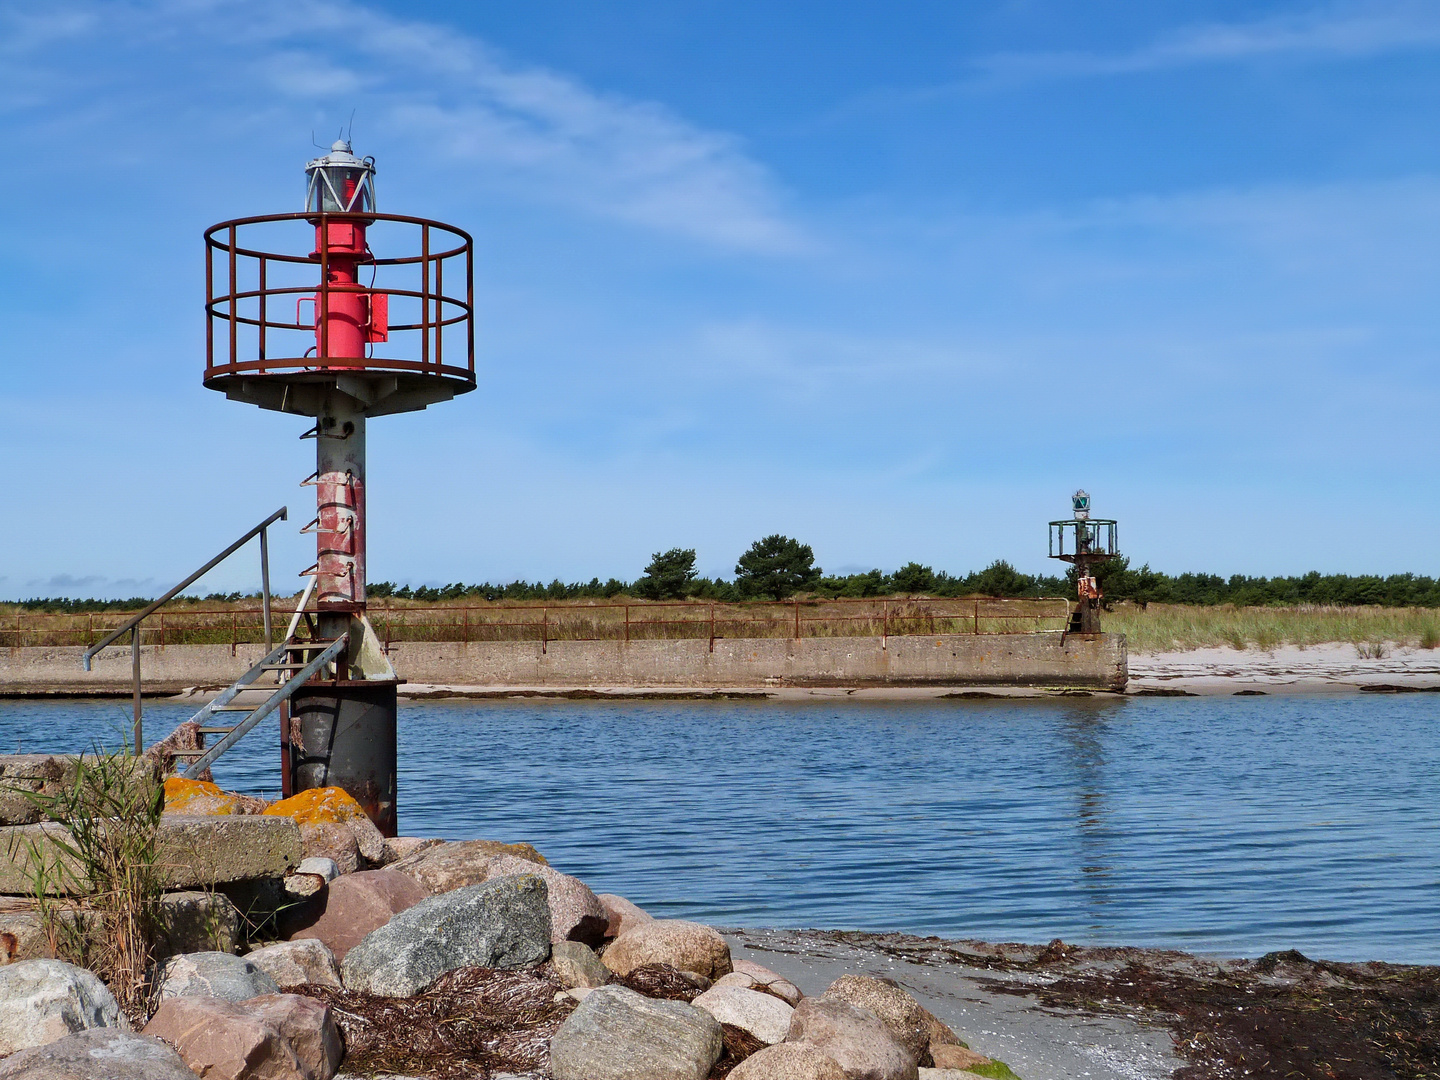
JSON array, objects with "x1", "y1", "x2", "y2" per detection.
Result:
[{"x1": 204, "y1": 213, "x2": 475, "y2": 393}]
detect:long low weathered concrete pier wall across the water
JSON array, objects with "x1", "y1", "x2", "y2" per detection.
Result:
[{"x1": 0, "y1": 634, "x2": 1128, "y2": 694}]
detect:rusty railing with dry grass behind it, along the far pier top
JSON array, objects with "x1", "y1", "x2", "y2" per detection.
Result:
[{"x1": 0, "y1": 596, "x2": 1070, "y2": 654}]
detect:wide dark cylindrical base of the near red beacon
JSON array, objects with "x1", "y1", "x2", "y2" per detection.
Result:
[{"x1": 289, "y1": 680, "x2": 400, "y2": 837}]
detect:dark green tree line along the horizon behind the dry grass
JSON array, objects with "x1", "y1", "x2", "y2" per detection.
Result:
[{"x1": 14, "y1": 534, "x2": 1440, "y2": 613}]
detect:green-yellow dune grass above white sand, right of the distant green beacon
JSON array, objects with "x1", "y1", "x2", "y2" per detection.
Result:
[{"x1": 1103, "y1": 603, "x2": 1440, "y2": 657}]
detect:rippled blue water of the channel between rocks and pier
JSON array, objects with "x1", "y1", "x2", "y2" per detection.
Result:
[{"x1": 0, "y1": 694, "x2": 1440, "y2": 963}]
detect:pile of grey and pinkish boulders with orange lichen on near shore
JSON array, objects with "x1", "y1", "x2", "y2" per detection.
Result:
[{"x1": 0, "y1": 759, "x2": 1002, "y2": 1080}]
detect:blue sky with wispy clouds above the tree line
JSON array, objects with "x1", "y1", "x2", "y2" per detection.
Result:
[{"x1": 0, "y1": 0, "x2": 1440, "y2": 596}]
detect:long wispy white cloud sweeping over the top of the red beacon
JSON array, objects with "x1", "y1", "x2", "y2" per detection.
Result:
[{"x1": 0, "y1": 0, "x2": 809, "y2": 255}]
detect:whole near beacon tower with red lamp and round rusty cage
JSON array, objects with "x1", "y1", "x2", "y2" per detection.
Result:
[{"x1": 204, "y1": 141, "x2": 475, "y2": 837}]
